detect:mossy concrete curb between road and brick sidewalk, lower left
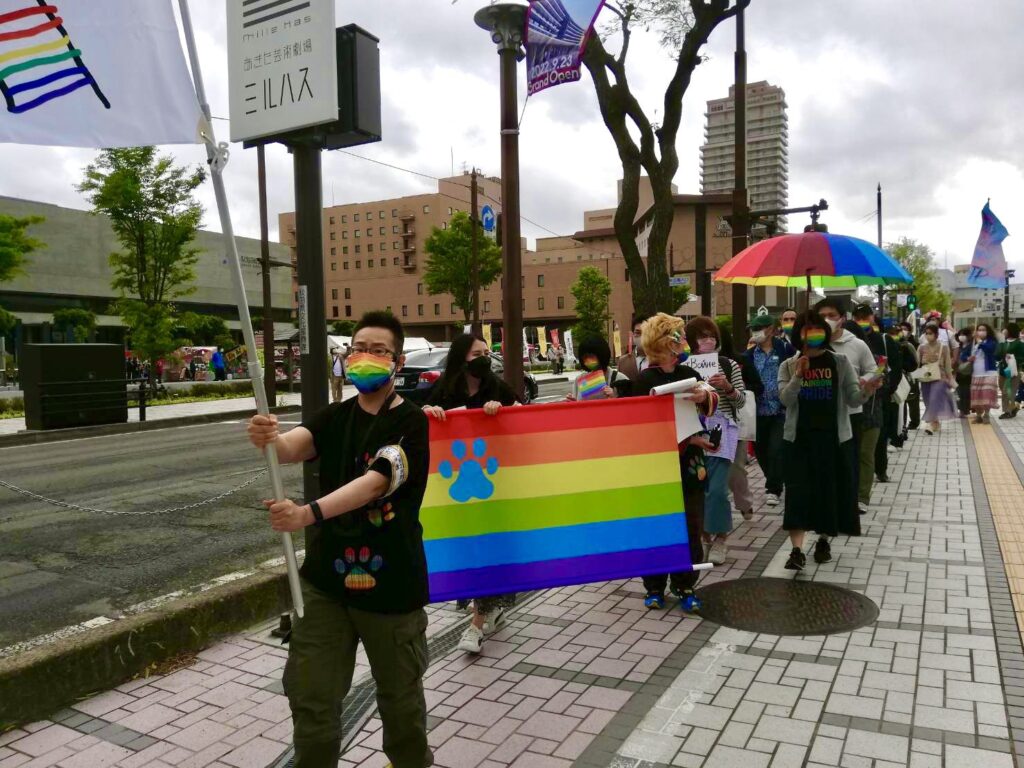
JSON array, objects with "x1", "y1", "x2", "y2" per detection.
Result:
[{"x1": 0, "y1": 567, "x2": 291, "y2": 732}]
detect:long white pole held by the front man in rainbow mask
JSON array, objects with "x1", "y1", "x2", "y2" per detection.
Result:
[{"x1": 178, "y1": 0, "x2": 303, "y2": 618}]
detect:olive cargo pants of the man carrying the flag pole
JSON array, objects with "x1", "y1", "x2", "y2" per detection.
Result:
[{"x1": 284, "y1": 580, "x2": 433, "y2": 768}]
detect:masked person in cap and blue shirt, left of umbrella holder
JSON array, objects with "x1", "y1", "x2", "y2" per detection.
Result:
[{"x1": 745, "y1": 314, "x2": 796, "y2": 507}]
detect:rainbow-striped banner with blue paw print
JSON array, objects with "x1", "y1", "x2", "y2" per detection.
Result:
[{"x1": 420, "y1": 397, "x2": 692, "y2": 602}]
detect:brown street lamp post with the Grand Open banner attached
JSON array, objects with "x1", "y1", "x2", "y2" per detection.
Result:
[{"x1": 473, "y1": 3, "x2": 526, "y2": 397}]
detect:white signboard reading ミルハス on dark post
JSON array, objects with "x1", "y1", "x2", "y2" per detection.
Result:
[{"x1": 227, "y1": 0, "x2": 338, "y2": 141}]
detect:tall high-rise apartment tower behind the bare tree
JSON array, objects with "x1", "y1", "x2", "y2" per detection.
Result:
[{"x1": 700, "y1": 80, "x2": 790, "y2": 231}]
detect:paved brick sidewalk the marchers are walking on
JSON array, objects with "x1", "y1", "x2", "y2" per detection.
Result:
[{"x1": 0, "y1": 422, "x2": 1024, "y2": 768}]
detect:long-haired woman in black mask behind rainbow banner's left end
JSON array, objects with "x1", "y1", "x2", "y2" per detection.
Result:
[{"x1": 423, "y1": 334, "x2": 521, "y2": 653}]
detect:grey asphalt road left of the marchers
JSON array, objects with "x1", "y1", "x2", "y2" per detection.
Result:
[{"x1": 0, "y1": 382, "x2": 569, "y2": 648}]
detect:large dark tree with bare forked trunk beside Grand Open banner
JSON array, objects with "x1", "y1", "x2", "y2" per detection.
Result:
[{"x1": 583, "y1": 0, "x2": 751, "y2": 314}]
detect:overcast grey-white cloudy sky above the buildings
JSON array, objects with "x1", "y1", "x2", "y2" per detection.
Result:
[{"x1": 0, "y1": 0, "x2": 1024, "y2": 276}]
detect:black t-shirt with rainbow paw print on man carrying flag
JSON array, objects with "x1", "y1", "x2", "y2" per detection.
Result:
[{"x1": 301, "y1": 397, "x2": 430, "y2": 613}]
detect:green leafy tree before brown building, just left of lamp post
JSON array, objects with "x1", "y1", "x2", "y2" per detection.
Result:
[{"x1": 423, "y1": 211, "x2": 502, "y2": 324}]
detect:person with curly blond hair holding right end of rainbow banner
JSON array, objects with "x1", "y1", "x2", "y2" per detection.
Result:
[{"x1": 633, "y1": 312, "x2": 718, "y2": 611}]
